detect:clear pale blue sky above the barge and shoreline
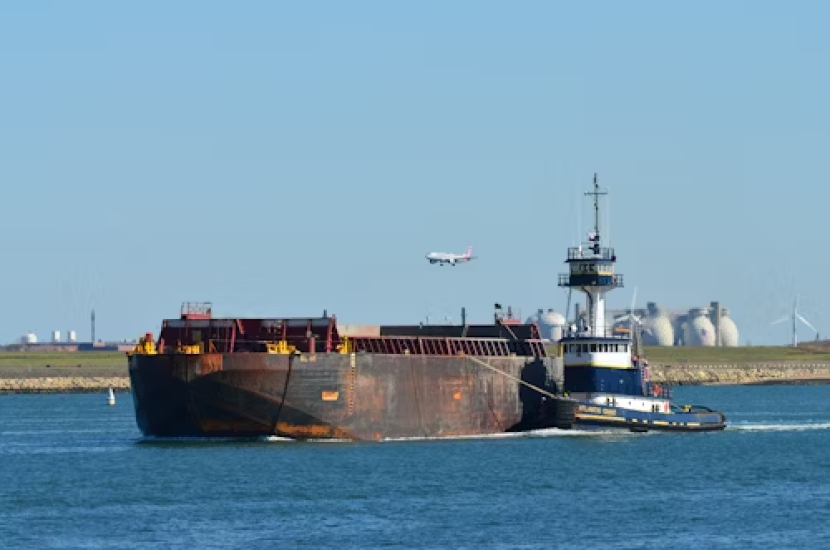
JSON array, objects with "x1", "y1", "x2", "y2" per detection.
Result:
[{"x1": 0, "y1": 0, "x2": 830, "y2": 344}]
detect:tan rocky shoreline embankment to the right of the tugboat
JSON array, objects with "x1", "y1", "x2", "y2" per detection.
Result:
[{"x1": 650, "y1": 361, "x2": 830, "y2": 386}]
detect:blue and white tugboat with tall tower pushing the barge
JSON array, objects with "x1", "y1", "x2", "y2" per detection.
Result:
[{"x1": 559, "y1": 174, "x2": 726, "y2": 432}]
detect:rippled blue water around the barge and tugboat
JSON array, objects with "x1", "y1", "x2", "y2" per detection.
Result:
[{"x1": 0, "y1": 386, "x2": 830, "y2": 549}]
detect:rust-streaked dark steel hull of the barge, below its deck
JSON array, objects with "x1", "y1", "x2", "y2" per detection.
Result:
[{"x1": 129, "y1": 353, "x2": 574, "y2": 440}]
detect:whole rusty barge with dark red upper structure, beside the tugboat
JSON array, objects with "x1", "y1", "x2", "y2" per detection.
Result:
[{"x1": 128, "y1": 304, "x2": 575, "y2": 441}]
